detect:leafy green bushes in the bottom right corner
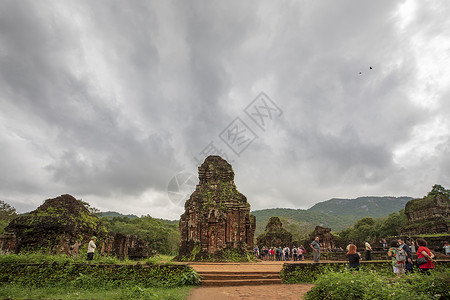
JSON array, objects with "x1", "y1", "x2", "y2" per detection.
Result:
[{"x1": 305, "y1": 269, "x2": 450, "y2": 300}]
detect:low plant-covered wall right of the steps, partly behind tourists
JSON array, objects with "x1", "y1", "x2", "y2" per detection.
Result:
[{"x1": 280, "y1": 260, "x2": 450, "y2": 283}]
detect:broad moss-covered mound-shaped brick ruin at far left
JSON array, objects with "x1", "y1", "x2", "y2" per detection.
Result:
[{"x1": 0, "y1": 195, "x2": 149, "y2": 258}]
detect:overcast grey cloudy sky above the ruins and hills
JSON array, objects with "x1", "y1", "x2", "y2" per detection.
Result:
[{"x1": 0, "y1": 0, "x2": 450, "y2": 219}]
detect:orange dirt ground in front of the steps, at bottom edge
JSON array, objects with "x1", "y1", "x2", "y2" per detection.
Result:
[{"x1": 188, "y1": 284, "x2": 313, "y2": 300}]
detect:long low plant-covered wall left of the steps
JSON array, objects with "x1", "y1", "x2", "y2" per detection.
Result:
[{"x1": 0, "y1": 262, "x2": 198, "y2": 287}]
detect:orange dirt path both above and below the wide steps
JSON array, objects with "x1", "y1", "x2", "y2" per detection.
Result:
[{"x1": 188, "y1": 261, "x2": 313, "y2": 300}]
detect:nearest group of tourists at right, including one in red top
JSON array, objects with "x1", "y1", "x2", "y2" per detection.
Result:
[{"x1": 346, "y1": 238, "x2": 436, "y2": 274}]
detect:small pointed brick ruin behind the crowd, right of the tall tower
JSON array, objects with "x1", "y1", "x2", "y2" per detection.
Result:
[{"x1": 256, "y1": 217, "x2": 292, "y2": 248}]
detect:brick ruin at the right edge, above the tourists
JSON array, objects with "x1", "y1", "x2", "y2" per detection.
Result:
[{"x1": 402, "y1": 193, "x2": 450, "y2": 236}]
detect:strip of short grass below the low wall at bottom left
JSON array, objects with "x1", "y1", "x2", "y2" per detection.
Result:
[{"x1": 0, "y1": 284, "x2": 192, "y2": 300}]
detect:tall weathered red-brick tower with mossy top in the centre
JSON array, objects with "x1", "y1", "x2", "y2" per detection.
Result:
[{"x1": 179, "y1": 156, "x2": 256, "y2": 259}]
